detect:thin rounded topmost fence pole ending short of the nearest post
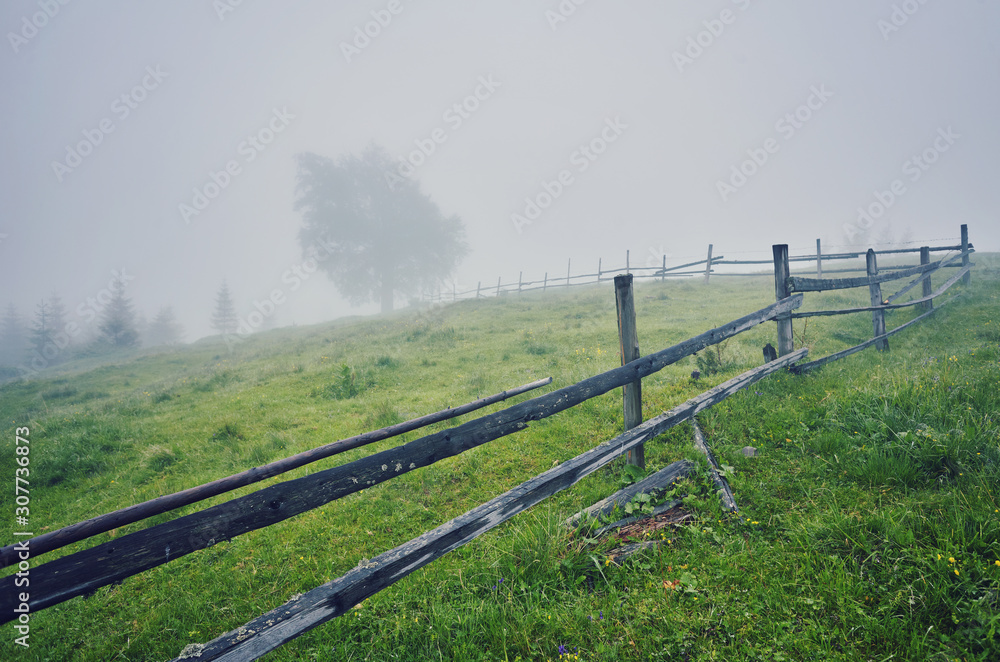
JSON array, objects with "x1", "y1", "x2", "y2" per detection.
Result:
[{"x1": 0, "y1": 377, "x2": 552, "y2": 568}]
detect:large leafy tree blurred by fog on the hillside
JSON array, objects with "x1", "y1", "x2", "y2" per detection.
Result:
[{"x1": 295, "y1": 145, "x2": 468, "y2": 312}]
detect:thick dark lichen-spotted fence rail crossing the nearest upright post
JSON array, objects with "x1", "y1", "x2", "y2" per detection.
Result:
[{"x1": 0, "y1": 294, "x2": 802, "y2": 623}]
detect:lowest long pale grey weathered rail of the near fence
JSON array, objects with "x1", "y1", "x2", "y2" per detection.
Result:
[{"x1": 174, "y1": 348, "x2": 808, "y2": 662}]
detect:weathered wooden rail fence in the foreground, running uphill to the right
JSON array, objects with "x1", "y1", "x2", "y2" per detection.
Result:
[{"x1": 0, "y1": 227, "x2": 972, "y2": 660}]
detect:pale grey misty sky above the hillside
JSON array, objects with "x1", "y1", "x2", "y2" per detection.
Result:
[{"x1": 0, "y1": 0, "x2": 1000, "y2": 340}]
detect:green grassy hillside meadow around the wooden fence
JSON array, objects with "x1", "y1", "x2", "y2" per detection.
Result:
[{"x1": 0, "y1": 254, "x2": 1000, "y2": 661}]
